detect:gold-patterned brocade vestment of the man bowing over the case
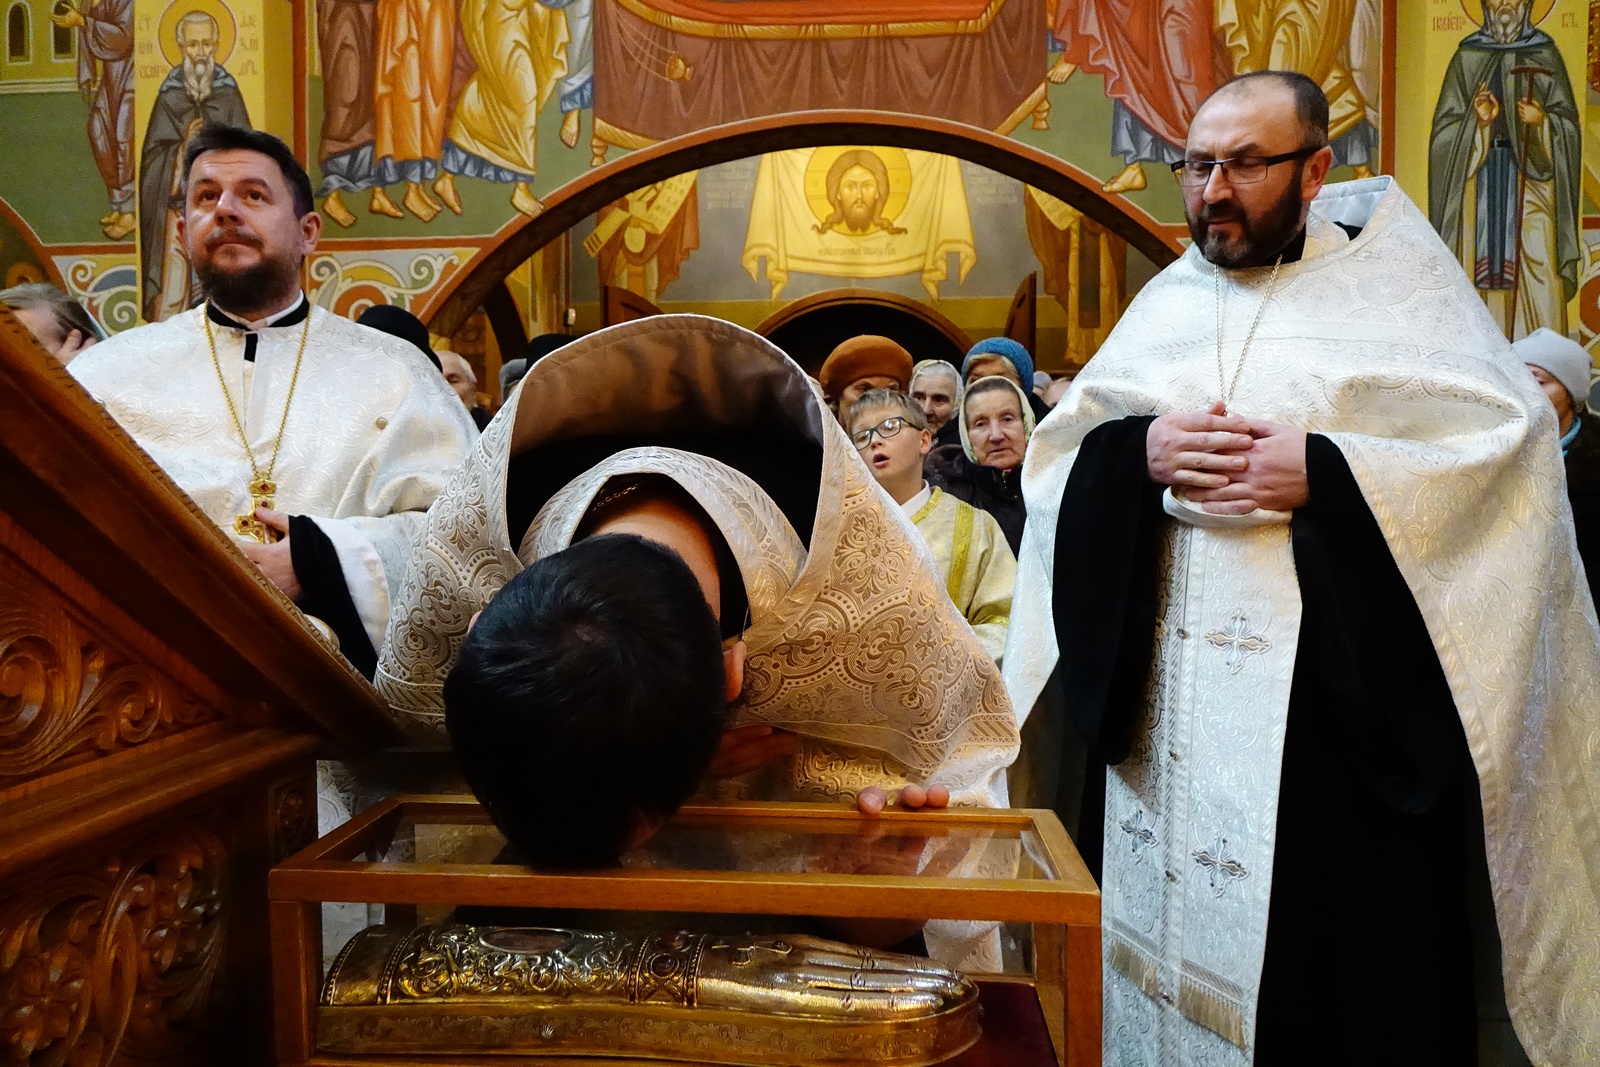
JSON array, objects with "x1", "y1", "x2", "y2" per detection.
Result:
[{"x1": 376, "y1": 315, "x2": 1018, "y2": 805}]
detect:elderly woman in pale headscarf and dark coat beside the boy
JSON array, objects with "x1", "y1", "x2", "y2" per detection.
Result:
[{"x1": 923, "y1": 374, "x2": 1034, "y2": 552}]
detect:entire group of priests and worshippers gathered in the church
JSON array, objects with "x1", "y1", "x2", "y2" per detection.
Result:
[{"x1": 0, "y1": 72, "x2": 1600, "y2": 1067}]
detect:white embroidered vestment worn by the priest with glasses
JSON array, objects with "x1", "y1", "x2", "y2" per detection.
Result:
[{"x1": 1005, "y1": 178, "x2": 1600, "y2": 1067}]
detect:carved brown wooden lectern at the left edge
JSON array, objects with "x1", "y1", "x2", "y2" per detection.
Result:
[{"x1": 0, "y1": 307, "x2": 398, "y2": 1067}]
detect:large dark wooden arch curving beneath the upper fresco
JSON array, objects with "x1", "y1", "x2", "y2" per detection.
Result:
[{"x1": 421, "y1": 110, "x2": 1182, "y2": 334}]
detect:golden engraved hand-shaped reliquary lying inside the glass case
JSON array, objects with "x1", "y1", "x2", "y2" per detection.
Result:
[{"x1": 317, "y1": 925, "x2": 979, "y2": 1067}]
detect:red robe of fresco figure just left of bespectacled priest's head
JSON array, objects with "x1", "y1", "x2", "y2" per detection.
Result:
[{"x1": 1056, "y1": 0, "x2": 1216, "y2": 147}]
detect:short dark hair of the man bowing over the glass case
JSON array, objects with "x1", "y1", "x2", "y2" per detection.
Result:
[{"x1": 445, "y1": 534, "x2": 738, "y2": 867}]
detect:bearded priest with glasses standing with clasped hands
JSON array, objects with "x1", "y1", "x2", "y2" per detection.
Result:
[{"x1": 1005, "y1": 75, "x2": 1600, "y2": 1067}]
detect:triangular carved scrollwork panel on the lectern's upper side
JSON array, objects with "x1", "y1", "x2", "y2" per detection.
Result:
[{"x1": 0, "y1": 553, "x2": 216, "y2": 782}]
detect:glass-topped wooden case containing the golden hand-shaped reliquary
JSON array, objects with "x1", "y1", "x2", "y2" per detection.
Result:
[{"x1": 269, "y1": 797, "x2": 1101, "y2": 1067}]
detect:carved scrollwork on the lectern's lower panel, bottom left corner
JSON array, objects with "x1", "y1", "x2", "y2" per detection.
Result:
[{"x1": 0, "y1": 829, "x2": 226, "y2": 1065}]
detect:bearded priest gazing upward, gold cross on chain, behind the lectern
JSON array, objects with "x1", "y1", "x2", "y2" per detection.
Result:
[{"x1": 69, "y1": 126, "x2": 475, "y2": 677}]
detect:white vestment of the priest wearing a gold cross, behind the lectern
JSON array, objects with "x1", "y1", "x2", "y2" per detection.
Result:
[{"x1": 67, "y1": 306, "x2": 477, "y2": 648}]
